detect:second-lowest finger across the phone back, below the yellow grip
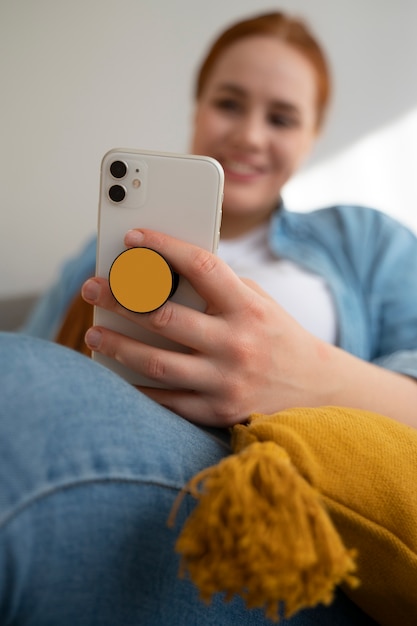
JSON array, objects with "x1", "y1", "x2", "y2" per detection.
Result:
[{"x1": 85, "y1": 326, "x2": 217, "y2": 392}]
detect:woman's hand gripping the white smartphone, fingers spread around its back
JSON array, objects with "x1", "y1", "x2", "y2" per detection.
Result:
[{"x1": 82, "y1": 231, "x2": 338, "y2": 426}]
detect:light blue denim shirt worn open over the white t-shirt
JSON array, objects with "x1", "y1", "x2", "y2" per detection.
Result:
[{"x1": 22, "y1": 205, "x2": 417, "y2": 378}]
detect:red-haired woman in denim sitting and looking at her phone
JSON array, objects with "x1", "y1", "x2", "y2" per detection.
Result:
[{"x1": 0, "y1": 14, "x2": 417, "y2": 625}]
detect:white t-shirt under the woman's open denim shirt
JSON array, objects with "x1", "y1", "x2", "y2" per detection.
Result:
[{"x1": 218, "y1": 225, "x2": 337, "y2": 344}]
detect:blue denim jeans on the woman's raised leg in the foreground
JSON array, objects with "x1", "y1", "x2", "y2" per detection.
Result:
[{"x1": 0, "y1": 333, "x2": 373, "y2": 626}]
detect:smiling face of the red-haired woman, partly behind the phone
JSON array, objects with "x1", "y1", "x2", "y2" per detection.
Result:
[{"x1": 192, "y1": 36, "x2": 317, "y2": 237}]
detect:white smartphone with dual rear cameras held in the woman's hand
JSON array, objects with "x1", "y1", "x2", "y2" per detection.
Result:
[{"x1": 93, "y1": 149, "x2": 224, "y2": 387}]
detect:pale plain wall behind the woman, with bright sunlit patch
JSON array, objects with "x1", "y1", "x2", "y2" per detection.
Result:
[{"x1": 0, "y1": 0, "x2": 417, "y2": 296}]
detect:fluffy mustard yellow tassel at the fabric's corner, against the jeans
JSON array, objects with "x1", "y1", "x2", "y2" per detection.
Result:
[{"x1": 169, "y1": 441, "x2": 358, "y2": 621}]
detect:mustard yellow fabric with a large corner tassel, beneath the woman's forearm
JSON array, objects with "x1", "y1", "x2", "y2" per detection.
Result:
[{"x1": 171, "y1": 407, "x2": 417, "y2": 626}]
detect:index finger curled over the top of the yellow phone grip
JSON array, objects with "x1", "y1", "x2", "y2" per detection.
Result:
[{"x1": 125, "y1": 229, "x2": 250, "y2": 313}]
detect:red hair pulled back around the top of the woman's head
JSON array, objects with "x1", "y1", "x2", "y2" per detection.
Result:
[{"x1": 195, "y1": 12, "x2": 331, "y2": 128}]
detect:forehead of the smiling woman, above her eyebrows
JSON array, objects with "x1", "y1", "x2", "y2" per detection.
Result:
[{"x1": 206, "y1": 35, "x2": 317, "y2": 104}]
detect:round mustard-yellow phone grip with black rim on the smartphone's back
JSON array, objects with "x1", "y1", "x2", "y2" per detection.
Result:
[{"x1": 109, "y1": 248, "x2": 179, "y2": 313}]
